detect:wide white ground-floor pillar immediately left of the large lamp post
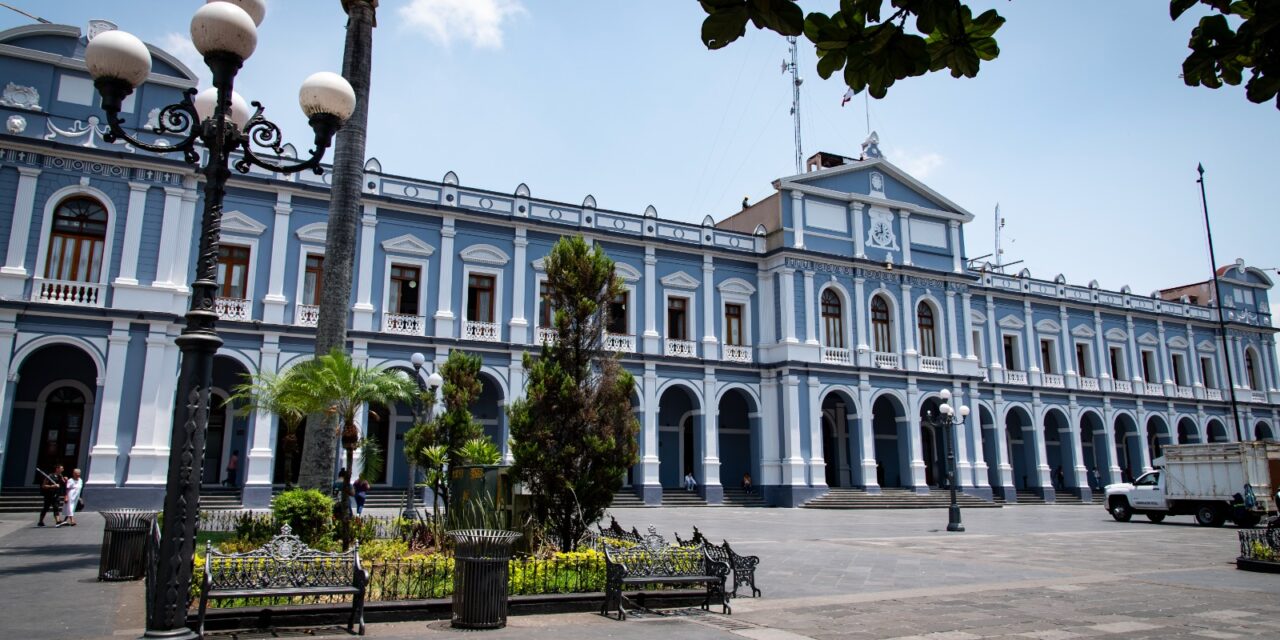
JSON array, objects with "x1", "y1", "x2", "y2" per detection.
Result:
[{"x1": 127, "y1": 324, "x2": 178, "y2": 485}]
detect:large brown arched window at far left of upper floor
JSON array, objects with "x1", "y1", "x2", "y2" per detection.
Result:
[{"x1": 45, "y1": 197, "x2": 108, "y2": 282}]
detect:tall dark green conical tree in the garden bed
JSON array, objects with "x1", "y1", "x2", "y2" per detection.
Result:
[{"x1": 508, "y1": 237, "x2": 640, "y2": 550}]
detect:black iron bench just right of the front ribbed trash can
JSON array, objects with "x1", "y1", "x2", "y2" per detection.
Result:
[{"x1": 600, "y1": 526, "x2": 732, "y2": 621}]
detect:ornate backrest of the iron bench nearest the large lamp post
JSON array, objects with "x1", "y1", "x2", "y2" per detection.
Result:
[{"x1": 205, "y1": 525, "x2": 364, "y2": 589}]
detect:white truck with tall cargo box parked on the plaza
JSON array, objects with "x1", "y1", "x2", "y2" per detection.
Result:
[{"x1": 1105, "y1": 442, "x2": 1280, "y2": 527}]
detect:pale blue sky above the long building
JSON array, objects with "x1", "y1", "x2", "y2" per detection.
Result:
[{"x1": 0, "y1": 0, "x2": 1280, "y2": 317}]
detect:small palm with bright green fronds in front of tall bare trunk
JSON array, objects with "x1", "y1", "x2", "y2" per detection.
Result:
[{"x1": 291, "y1": 348, "x2": 417, "y2": 543}]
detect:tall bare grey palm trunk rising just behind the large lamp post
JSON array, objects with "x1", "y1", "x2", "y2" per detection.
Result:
[{"x1": 298, "y1": 0, "x2": 378, "y2": 490}]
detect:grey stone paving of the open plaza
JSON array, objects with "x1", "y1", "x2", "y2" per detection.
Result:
[{"x1": 0, "y1": 506, "x2": 1280, "y2": 640}]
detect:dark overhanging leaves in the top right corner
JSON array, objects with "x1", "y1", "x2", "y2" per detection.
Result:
[{"x1": 1169, "y1": 0, "x2": 1280, "y2": 109}]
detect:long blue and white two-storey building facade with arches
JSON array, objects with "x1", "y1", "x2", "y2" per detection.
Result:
[{"x1": 0, "y1": 22, "x2": 1280, "y2": 507}]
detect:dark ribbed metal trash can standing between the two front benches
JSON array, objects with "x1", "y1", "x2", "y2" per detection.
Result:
[{"x1": 448, "y1": 529, "x2": 520, "y2": 628}]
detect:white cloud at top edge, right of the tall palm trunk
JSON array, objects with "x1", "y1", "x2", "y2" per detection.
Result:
[{"x1": 399, "y1": 0, "x2": 527, "y2": 49}]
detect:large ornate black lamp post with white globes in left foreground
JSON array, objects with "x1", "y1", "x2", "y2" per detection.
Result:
[{"x1": 84, "y1": 0, "x2": 356, "y2": 639}]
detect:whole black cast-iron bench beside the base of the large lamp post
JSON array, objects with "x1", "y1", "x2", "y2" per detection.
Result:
[{"x1": 197, "y1": 525, "x2": 369, "y2": 637}]
